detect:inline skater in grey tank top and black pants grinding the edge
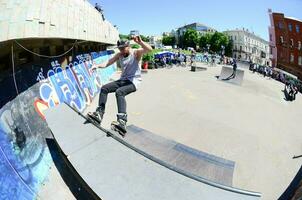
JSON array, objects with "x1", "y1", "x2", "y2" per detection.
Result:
[{"x1": 88, "y1": 36, "x2": 152, "y2": 134}]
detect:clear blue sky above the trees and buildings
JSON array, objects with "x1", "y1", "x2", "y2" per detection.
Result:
[{"x1": 89, "y1": 0, "x2": 302, "y2": 40}]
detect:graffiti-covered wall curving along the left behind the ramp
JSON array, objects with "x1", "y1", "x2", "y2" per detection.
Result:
[{"x1": 0, "y1": 51, "x2": 116, "y2": 199}]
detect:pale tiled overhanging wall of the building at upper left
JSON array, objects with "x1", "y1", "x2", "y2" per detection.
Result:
[{"x1": 0, "y1": 0, "x2": 119, "y2": 44}]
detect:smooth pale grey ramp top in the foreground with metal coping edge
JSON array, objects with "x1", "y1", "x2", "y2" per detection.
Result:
[{"x1": 45, "y1": 104, "x2": 261, "y2": 200}]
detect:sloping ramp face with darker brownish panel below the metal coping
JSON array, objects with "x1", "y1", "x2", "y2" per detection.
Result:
[{"x1": 124, "y1": 125, "x2": 235, "y2": 186}]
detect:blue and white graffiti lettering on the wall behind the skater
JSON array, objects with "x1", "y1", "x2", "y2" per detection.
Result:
[{"x1": 40, "y1": 51, "x2": 116, "y2": 111}]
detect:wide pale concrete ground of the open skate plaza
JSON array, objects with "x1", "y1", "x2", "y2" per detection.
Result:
[{"x1": 86, "y1": 65, "x2": 302, "y2": 200}]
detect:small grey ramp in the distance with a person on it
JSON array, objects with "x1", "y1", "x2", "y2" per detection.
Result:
[{"x1": 218, "y1": 66, "x2": 244, "y2": 85}]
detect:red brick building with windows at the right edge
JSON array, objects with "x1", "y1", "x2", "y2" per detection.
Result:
[{"x1": 269, "y1": 10, "x2": 302, "y2": 80}]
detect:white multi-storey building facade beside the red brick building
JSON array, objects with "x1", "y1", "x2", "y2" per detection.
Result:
[{"x1": 224, "y1": 29, "x2": 271, "y2": 66}]
